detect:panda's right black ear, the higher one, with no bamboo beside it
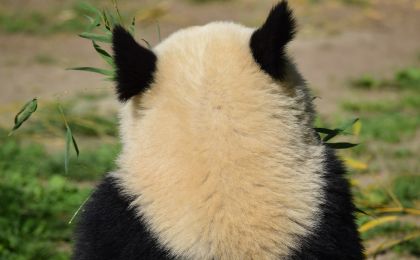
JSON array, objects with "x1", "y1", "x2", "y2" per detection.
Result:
[{"x1": 250, "y1": 0, "x2": 296, "y2": 80}]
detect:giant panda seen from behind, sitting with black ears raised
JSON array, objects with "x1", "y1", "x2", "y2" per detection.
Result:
[{"x1": 73, "y1": 1, "x2": 363, "y2": 260}]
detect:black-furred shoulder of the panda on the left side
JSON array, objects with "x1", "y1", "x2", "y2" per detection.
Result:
[{"x1": 74, "y1": 174, "x2": 175, "y2": 259}]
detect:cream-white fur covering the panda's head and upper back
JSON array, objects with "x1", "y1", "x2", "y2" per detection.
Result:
[{"x1": 114, "y1": 22, "x2": 325, "y2": 260}]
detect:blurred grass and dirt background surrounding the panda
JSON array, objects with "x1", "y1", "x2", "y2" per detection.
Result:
[{"x1": 0, "y1": 0, "x2": 420, "y2": 259}]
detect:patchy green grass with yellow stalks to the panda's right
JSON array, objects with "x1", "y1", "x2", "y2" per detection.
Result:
[{"x1": 338, "y1": 67, "x2": 420, "y2": 257}]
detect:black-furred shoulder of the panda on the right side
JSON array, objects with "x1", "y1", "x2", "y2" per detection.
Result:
[{"x1": 290, "y1": 149, "x2": 363, "y2": 259}]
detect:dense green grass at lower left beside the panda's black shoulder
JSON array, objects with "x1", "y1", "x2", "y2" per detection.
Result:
[{"x1": 0, "y1": 135, "x2": 118, "y2": 260}]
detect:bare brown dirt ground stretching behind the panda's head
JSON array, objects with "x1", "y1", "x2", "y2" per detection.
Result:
[{"x1": 0, "y1": 0, "x2": 420, "y2": 116}]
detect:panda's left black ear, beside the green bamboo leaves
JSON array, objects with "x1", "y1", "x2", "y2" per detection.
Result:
[{"x1": 112, "y1": 25, "x2": 157, "y2": 102}]
